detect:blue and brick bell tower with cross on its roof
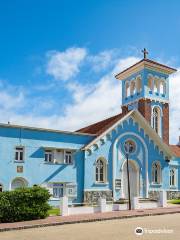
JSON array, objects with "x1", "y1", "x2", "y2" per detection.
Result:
[{"x1": 115, "y1": 49, "x2": 176, "y2": 144}]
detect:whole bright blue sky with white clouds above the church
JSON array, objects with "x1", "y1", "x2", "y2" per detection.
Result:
[{"x1": 0, "y1": 0, "x2": 180, "y2": 142}]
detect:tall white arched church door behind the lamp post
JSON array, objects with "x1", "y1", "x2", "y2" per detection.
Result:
[{"x1": 122, "y1": 160, "x2": 139, "y2": 199}]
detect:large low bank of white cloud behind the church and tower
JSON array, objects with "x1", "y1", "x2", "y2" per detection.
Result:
[{"x1": 0, "y1": 51, "x2": 180, "y2": 143}]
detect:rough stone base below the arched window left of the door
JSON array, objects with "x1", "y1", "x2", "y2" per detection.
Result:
[{"x1": 84, "y1": 190, "x2": 113, "y2": 204}]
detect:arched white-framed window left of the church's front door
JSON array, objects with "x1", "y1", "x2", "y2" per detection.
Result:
[{"x1": 96, "y1": 158, "x2": 107, "y2": 183}]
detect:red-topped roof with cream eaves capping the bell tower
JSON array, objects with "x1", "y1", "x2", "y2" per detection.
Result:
[{"x1": 115, "y1": 58, "x2": 177, "y2": 80}]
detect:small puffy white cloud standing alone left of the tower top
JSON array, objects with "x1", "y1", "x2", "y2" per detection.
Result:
[{"x1": 46, "y1": 48, "x2": 87, "y2": 81}]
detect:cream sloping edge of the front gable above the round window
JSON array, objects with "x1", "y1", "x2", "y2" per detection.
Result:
[{"x1": 83, "y1": 110, "x2": 174, "y2": 157}]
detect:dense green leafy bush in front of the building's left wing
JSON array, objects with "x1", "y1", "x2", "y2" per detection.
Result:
[{"x1": 0, "y1": 186, "x2": 50, "y2": 222}]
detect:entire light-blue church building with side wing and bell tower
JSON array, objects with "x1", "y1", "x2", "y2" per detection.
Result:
[{"x1": 0, "y1": 55, "x2": 180, "y2": 205}]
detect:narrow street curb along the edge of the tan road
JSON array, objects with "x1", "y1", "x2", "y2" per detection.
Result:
[{"x1": 0, "y1": 210, "x2": 180, "y2": 232}]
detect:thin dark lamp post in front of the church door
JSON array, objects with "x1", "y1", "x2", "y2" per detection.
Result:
[{"x1": 124, "y1": 141, "x2": 134, "y2": 210}]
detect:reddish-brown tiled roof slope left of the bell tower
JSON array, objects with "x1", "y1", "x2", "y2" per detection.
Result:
[{"x1": 76, "y1": 113, "x2": 125, "y2": 135}]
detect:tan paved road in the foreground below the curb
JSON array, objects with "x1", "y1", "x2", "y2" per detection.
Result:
[{"x1": 0, "y1": 214, "x2": 180, "y2": 240}]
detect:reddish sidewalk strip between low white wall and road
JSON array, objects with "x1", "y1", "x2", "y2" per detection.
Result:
[{"x1": 0, "y1": 207, "x2": 180, "y2": 232}]
